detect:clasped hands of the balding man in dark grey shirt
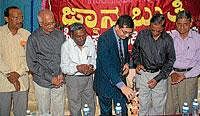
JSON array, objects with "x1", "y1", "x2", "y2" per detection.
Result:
[{"x1": 51, "y1": 75, "x2": 64, "y2": 88}]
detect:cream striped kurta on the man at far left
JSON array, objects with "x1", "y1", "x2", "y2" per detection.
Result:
[{"x1": 0, "y1": 25, "x2": 30, "y2": 92}]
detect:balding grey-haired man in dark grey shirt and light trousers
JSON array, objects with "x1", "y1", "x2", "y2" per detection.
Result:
[{"x1": 27, "y1": 9, "x2": 65, "y2": 116}]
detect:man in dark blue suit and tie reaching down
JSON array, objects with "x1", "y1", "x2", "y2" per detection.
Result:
[{"x1": 94, "y1": 15, "x2": 134, "y2": 116}]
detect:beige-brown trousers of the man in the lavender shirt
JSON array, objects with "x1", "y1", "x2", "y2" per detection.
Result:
[{"x1": 166, "y1": 77, "x2": 198, "y2": 114}]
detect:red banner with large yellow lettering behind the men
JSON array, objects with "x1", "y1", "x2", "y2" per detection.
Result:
[{"x1": 42, "y1": 0, "x2": 200, "y2": 49}]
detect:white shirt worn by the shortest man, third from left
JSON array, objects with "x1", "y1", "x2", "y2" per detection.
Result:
[{"x1": 61, "y1": 36, "x2": 96, "y2": 75}]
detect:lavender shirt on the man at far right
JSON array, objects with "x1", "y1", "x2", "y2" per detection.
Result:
[{"x1": 170, "y1": 30, "x2": 200, "y2": 78}]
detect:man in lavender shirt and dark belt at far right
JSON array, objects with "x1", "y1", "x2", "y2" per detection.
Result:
[{"x1": 166, "y1": 10, "x2": 200, "y2": 114}]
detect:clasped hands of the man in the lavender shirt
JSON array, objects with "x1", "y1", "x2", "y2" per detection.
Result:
[{"x1": 170, "y1": 72, "x2": 186, "y2": 85}]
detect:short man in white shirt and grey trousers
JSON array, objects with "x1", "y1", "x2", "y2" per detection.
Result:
[{"x1": 61, "y1": 23, "x2": 96, "y2": 116}]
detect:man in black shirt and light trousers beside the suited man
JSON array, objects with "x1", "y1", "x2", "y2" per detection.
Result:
[{"x1": 132, "y1": 14, "x2": 175, "y2": 116}]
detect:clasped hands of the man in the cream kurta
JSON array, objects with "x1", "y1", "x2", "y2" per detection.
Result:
[{"x1": 7, "y1": 71, "x2": 20, "y2": 91}]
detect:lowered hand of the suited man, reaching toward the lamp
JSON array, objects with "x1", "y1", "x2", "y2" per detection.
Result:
[{"x1": 120, "y1": 85, "x2": 135, "y2": 102}]
